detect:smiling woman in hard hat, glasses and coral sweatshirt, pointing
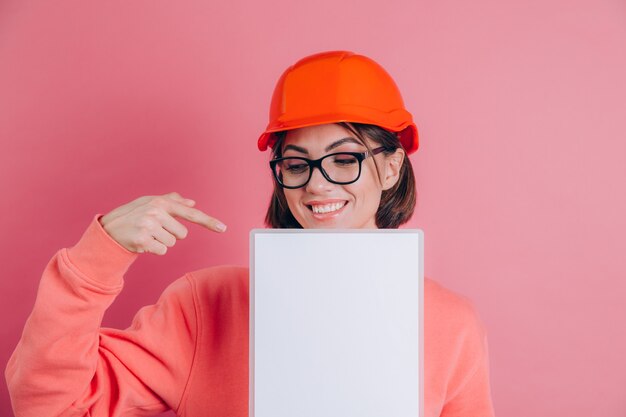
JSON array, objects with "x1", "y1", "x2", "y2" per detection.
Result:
[{"x1": 6, "y1": 51, "x2": 493, "y2": 417}]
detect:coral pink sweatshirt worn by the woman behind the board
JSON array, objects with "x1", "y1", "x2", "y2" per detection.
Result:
[{"x1": 5, "y1": 214, "x2": 493, "y2": 417}]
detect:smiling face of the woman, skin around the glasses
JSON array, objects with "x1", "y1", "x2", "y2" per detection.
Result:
[{"x1": 282, "y1": 124, "x2": 403, "y2": 229}]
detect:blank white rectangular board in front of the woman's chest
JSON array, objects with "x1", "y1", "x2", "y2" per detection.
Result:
[{"x1": 249, "y1": 229, "x2": 423, "y2": 417}]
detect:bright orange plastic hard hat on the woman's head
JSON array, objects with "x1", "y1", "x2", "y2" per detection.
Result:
[{"x1": 258, "y1": 51, "x2": 418, "y2": 154}]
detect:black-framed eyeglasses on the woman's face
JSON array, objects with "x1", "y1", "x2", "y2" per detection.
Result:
[{"x1": 270, "y1": 146, "x2": 385, "y2": 188}]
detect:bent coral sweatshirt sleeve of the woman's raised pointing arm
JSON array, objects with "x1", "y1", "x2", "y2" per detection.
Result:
[{"x1": 5, "y1": 214, "x2": 196, "y2": 417}]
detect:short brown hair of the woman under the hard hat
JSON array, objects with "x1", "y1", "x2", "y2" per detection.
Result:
[{"x1": 265, "y1": 122, "x2": 417, "y2": 229}]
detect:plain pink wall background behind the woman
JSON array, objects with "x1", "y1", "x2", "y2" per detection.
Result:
[{"x1": 0, "y1": 0, "x2": 626, "y2": 417}]
